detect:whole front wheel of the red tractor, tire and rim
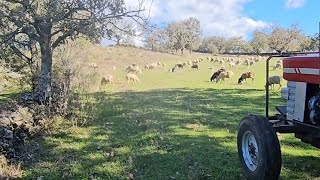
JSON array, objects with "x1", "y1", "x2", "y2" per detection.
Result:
[{"x1": 237, "y1": 115, "x2": 282, "y2": 180}]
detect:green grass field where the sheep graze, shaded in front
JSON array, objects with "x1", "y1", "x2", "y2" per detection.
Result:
[{"x1": 3, "y1": 48, "x2": 320, "y2": 180}]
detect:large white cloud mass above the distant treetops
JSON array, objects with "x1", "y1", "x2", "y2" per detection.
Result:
[{"x1": 125, "y1": 0, "x2": 269, "y2": 45}]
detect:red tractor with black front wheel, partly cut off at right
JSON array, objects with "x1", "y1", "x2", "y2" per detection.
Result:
[{"x1": 237, "y1": 53, "x2": 320, "y2": 180}]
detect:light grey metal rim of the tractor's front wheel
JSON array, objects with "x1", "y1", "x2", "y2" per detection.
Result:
[{"x1": 242, "y1": 131, "x2": 259, "y2": 171}]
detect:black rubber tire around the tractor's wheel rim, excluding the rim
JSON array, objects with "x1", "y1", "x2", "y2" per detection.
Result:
[{"x1": 237, "y1": 115, "x2": 282, "y2": 180}]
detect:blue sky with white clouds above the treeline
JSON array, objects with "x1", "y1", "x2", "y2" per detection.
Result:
[{"x1": 104, "y1": 0, "x2": 320, "y2": 43}]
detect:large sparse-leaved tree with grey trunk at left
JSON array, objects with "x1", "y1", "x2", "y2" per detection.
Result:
[{"x1": 0, "y1": 0, "x2": 147, "y2": 102}]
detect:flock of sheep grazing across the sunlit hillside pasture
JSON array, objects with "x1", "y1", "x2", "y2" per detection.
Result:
[{"x1": 95, "y1": 56, "x2": 282, "y2": 88}]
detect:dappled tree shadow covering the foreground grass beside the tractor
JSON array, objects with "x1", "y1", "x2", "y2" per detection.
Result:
[{"x1": 24, "y1": 89, "x2": 320, "y2": 180}]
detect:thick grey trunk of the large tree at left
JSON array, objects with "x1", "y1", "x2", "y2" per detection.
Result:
[{"x1": 38, "y1": 36, "x2": 52, "y2": 103}]
